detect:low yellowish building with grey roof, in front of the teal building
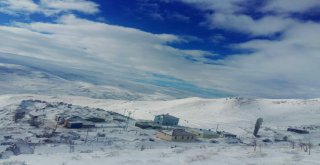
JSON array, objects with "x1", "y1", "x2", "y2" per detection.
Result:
[{"x1": 156, "y1": 129, "x2": 195, "y2": 142}]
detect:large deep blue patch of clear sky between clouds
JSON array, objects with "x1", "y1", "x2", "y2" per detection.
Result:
[{"x1": 89, "y1": 0, "x2": 252, "y2": 56}]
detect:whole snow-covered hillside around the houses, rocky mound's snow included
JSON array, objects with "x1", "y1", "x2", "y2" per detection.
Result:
[{"x1": 0, "y1": 94, "x2": 320, "y2": 165}]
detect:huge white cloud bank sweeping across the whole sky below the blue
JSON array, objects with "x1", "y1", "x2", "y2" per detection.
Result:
[{"x1": 0, "y1": 0, "x2": 320, "y2": 98}]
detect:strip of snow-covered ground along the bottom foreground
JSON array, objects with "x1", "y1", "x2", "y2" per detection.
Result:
[{"x1": 6, "y1": 146, "x2": 320, "y2": 165}]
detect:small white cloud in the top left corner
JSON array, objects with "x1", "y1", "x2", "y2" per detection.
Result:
[{"x1": 0, "y1": 0, "x2": 99, "y2": 15}]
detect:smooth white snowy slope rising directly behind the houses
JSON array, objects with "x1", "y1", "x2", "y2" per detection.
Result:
[{"x1": 0, "y1": 95, "x2": 320, "y2": 133}]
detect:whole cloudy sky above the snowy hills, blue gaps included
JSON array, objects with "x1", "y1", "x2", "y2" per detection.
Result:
[{"x1": 0, "y1": 0, "x2": 320, "y2": 98}]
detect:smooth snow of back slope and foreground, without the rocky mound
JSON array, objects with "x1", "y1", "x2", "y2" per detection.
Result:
[{"x1": 0, "y1": 95, "x2": 320, "y2": 165}]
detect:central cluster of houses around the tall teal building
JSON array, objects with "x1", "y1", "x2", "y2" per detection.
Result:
[{"x1": 135, "y1": 114, "x2": 236, "y2": 142}]
